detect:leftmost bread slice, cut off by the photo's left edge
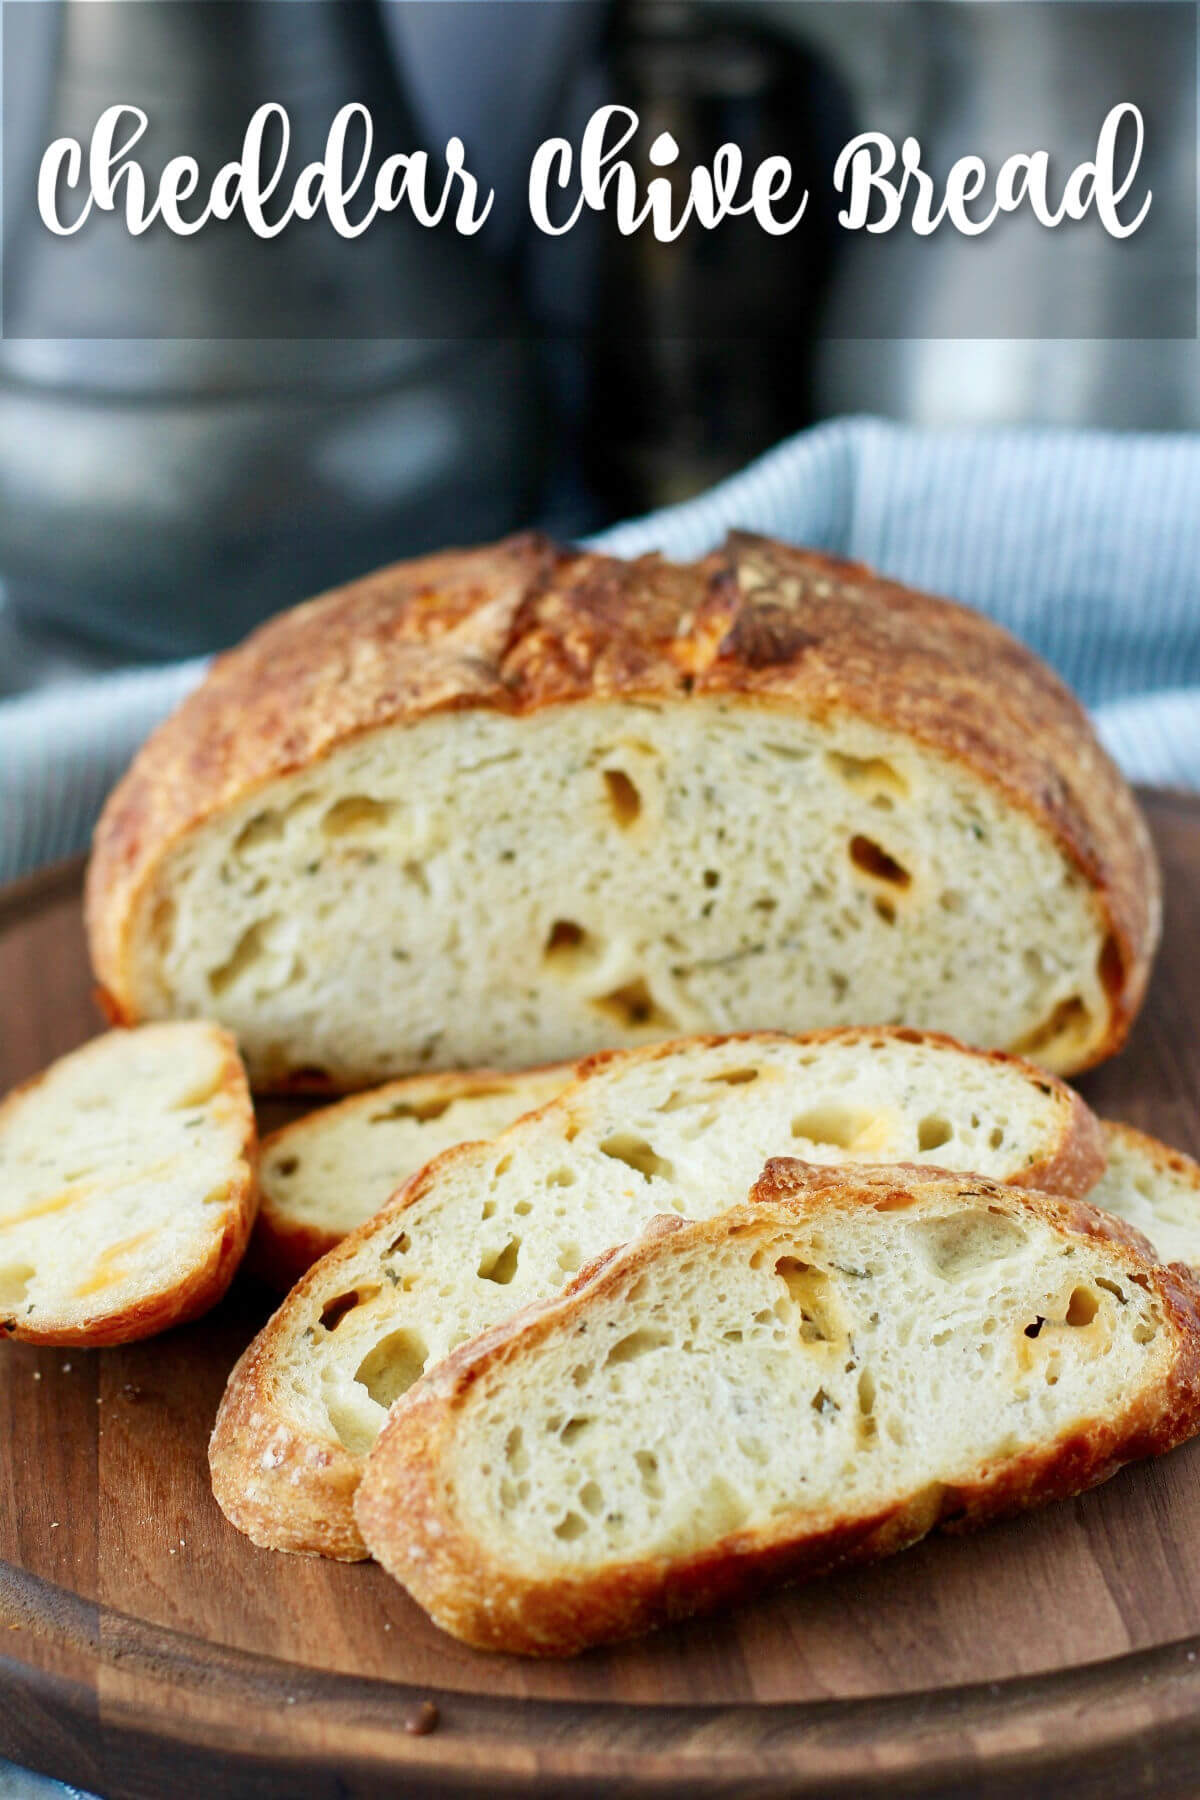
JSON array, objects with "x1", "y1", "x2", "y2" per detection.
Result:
[{"x1": 0, "y1": 1024, "x2": 257, "y2": 1345}]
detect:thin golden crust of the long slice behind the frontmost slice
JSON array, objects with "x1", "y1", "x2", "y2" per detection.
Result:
[{"x1": 209, "y1": 1026, "x2": 1106, "y2": 1561}]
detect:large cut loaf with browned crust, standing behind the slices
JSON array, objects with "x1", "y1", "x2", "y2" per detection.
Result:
[{"x1": 86, "y1": 533, "x2": 1159, "y2": 1089}]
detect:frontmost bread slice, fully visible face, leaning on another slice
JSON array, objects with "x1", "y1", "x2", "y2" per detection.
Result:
[{"x1": 356, "y1": 1161, "x2": 1200, "y2": 1656}]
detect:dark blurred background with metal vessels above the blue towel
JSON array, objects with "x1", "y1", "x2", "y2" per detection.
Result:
[{"x1": 0, "y1": 0, "x2": 1200, "y2": 680}]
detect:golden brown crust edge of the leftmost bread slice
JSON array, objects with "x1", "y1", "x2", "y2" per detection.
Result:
[{"x1": 0, "y1": 1026, "x2": 259, "y2": 1350}]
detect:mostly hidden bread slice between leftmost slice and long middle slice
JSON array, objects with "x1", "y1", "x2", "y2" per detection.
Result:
[{"x1": 250, "y1": 1062, "x2": 576, "y2": 1289}]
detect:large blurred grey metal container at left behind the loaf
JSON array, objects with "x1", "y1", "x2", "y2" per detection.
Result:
[{"x1": 0, "y1": 0, "x2": 538, "y2": 653}]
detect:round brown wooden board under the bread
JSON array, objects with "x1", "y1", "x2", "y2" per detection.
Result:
[{"x1": 0, "y1": 794, "x2": 1200, "y2": 1800}]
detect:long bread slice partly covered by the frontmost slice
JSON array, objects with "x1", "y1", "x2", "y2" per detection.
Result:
[{"x1": 210, "y1": 1030, "x2": 1103, "y2": 1557}]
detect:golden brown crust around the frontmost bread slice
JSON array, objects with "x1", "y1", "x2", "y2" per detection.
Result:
[{"x1": 356, "y1": 1161, "x2": 1200, "y2": 1656}]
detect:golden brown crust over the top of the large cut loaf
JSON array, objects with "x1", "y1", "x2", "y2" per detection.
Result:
[{"x1": 86, "y1": 533, "x2": 1160, "y2": 1062}]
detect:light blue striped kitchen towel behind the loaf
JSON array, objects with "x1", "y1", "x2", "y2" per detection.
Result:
[{"x1": 0, "y1": 419, "x2": 1200, "y2": 880}]
